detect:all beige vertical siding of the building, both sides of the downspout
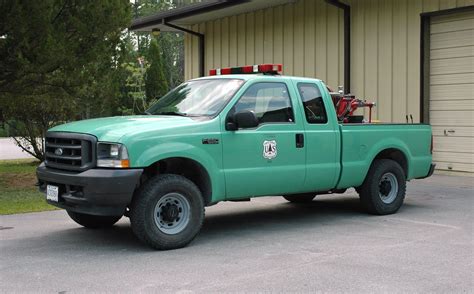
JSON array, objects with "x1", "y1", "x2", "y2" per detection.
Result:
[{"x1": 185, "y1": 0, "x2": 474, "y2": 122}]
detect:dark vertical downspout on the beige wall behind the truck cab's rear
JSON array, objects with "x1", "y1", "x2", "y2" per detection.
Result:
[{"x1": 326, "y1": 0, "x2": 351, "y2": 94}]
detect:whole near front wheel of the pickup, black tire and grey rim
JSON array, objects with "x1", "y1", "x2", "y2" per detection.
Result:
[{"x1": 130, "y1": 174, "x2": 204, "y2": 250}]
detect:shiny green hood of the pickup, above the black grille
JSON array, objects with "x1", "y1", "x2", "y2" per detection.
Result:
[{"x1": 49, "y1": 115, "x2": 196, "y2": 142}]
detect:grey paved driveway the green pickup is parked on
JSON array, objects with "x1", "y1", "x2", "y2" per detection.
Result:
[{"x1": 0, "y1": 176, "x2": 474, "y2": 293}]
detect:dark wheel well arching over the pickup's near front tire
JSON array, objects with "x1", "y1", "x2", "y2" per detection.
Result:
[{"x1": 140, "y1": 157, "x2": 212, "y2": 205}]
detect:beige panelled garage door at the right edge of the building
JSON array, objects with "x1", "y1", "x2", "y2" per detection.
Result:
[{"x1": 429, "y1": 11, "x2": 474, "y2": 173}]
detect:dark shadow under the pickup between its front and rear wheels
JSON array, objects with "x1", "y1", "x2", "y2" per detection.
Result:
[{"x1": 198, "y1": 195, "x2": 420, "y2": 243}]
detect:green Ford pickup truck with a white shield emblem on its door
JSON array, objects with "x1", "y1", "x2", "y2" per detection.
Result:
[{"x1": 37, "y1": 65, "x2": 434, "y2": 249}]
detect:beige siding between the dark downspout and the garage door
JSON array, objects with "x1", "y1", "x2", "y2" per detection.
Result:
[{"x1": 346, "y1": 0, "x2": 474, "y2": 122}]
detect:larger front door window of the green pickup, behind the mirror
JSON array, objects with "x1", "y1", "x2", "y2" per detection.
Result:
[{"x1": 234, "y1": 83, "x2": 294, "y2": 123}]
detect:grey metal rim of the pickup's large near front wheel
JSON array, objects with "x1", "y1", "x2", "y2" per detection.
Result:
[{"x1": 154, "y1": 193, "x2": 191, "y2": 235}]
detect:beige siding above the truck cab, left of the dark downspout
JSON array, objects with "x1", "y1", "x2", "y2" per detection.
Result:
[{"x1": 185, "y1": 0, "x2": 344, "y2": 87}]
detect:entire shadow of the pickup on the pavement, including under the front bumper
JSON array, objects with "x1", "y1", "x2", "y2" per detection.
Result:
[{"x1": 16, "y1": 197, "x2": 420, "y2": 254}]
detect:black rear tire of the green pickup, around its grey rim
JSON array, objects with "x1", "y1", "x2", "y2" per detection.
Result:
[{"x1": 358, "y1": 159, "x2": 406, "y2": 215}]
